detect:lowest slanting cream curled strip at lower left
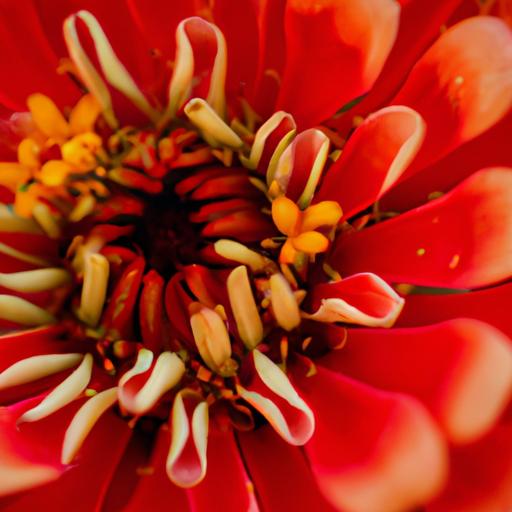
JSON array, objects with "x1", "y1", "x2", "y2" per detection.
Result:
[{"x1": 61, "y1": 388, "x2": 117, "y2": 464}]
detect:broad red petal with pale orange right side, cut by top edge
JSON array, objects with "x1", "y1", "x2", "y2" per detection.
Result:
[{"x1": 277, "y1": 0, "x2": 400, "y2": 127}]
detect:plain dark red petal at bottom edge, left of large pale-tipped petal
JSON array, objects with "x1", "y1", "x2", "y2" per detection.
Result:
[{"x1": 238, "y1": 427, "x2": 335, "y2": 512}]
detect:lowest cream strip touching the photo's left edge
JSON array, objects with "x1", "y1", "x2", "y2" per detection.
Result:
[{"x1": 0, "y1": 354, "x2": 83, "y2": 389}]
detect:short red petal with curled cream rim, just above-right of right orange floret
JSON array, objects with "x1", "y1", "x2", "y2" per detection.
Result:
[{"x1": 318, "y1": 107, "x2": 425, "y2": 217}]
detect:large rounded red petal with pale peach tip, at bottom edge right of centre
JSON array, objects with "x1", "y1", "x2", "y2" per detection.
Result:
[{"x1": 296, "y1": 368, "x2": 447, "y2": 512}]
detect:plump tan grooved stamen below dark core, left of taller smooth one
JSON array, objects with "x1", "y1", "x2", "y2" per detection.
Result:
[{"x1": 190, "y1": 307, "x2": 234, "y2": 376}]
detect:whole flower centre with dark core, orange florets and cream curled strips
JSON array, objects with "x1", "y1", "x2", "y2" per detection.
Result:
[{"x1": 0, "y1": 12, "x2": 403, "y2": 487}]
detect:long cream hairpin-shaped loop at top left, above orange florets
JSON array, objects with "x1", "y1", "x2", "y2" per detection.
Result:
[{"x1": 64, "y1": 11, "x2": 159, "y2": 122}]
